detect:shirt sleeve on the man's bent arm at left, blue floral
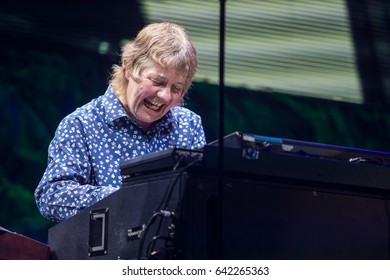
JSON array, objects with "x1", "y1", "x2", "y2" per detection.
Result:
[{"x1": 35, "y1": 118, "x2": 119, "y2": 222}]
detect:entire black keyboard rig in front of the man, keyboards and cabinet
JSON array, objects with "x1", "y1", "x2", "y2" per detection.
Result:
[{"x1": 49, "y1": 132, "x2": 390, "y2": 259}]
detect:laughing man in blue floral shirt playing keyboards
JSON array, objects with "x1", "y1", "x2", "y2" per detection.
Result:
[{"x1": 35, "y1": 22, "x2": 206, "y2": 221}]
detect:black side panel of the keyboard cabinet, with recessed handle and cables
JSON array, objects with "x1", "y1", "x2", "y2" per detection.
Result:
[{"x1": 48, "y1": 172, "x2": 187, "y2": 259}]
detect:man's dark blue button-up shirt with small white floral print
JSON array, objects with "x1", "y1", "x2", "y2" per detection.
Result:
[{"x1": 35, "y1": 86, "x2": 206, "y2": 221}]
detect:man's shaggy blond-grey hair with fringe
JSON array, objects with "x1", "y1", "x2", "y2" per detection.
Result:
[{"x1": 109, "y1": 22, "x2": 198, "y2": 100}]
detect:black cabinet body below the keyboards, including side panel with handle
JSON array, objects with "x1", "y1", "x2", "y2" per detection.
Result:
[{"x1": 49, "y1": 168, "x2": 389, "y2": 260}]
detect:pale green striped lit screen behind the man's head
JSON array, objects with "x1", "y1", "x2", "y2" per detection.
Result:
[{"x1": 141, "y1": 0, "x2": 362, "y2": 103}]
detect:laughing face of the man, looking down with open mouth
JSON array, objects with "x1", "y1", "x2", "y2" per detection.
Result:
[{"x1": 124, "y1": 66, "x2": 184, "y2": 129}]
